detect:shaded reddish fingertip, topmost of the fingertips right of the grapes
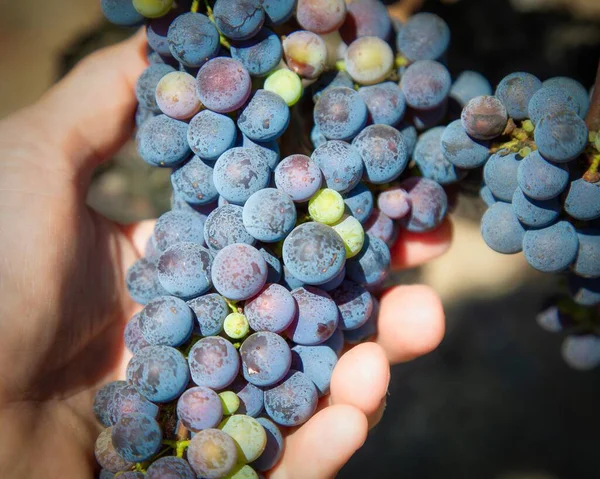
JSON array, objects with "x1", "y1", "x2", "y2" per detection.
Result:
[{"x1": 390, "y1": 218, "x2": 452, "y2": 269}]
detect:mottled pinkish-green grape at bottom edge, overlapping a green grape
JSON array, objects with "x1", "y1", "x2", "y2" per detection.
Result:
[{"x1": 187, "y1": 429, "x2": 238, "y2": 479}]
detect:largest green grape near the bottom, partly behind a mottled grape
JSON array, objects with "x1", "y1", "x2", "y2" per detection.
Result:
[{"x1": 219, "y1": 414, "x2": 267, "y2": 464}]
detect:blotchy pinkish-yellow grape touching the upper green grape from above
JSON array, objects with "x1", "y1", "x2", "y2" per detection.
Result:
[{"x1": 283, "y1": 30, "x2": 327, "y2": 79}]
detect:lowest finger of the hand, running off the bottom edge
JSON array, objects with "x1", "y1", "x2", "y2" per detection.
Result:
[{"x1": 269, "y1": 405, "x2": 368, "y2": 479}]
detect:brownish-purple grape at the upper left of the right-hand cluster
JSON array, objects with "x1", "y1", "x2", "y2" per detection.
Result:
[{"x1": 460, "y1": 96, "x2": 508, "y2": 140}]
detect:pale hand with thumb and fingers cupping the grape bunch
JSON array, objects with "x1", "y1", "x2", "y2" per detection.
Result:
[{"x1": 0, "y1": 34, "x2": 451, "y2": 479}]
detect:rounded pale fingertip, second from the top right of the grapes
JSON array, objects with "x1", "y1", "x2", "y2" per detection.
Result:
[{"x1": 376, "y1": 285, "x2": 445, "y2": 364}]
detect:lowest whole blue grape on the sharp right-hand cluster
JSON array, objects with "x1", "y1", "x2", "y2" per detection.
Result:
[{"x1": 523, "y1": 221, "x2": 579, "y2": 273}]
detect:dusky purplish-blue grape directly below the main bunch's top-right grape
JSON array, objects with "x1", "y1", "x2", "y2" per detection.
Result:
[{"x1": 400, "y1": 60, "x2": 452, "y2": 110}]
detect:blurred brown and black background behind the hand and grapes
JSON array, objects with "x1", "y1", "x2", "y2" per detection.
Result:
[{"x1": 0, "y1": 0, "x2": 600, "y2": 479}]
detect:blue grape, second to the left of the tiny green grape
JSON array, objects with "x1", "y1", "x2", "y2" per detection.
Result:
[{"x1": 140, "y1": 296, "x2": 194, "y2": 347}]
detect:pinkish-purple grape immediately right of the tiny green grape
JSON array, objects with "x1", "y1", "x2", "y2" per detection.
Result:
[{"x1": 244, "y1": 284, "x2": 296, "y2": 333}]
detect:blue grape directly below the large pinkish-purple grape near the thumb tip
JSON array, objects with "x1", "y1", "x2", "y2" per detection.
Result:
[{"x1": 187, "y1": 110, "x2": 237, "y2": 161}]
